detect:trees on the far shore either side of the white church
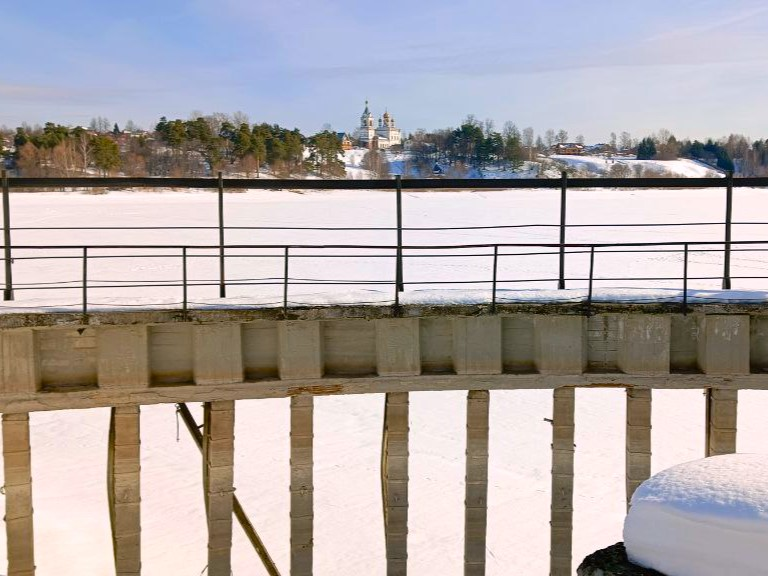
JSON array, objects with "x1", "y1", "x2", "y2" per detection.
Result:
[{"x1": 0, "y1": 112, "x2": 768, "y2": 178}]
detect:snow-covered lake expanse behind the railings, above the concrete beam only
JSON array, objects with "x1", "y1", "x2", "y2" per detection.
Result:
[{"x1": 4, "y1": 184, "x2": 768, "y2": 310}]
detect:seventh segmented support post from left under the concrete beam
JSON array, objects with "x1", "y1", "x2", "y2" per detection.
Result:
[{"x1": 549, "y1": 388, "x2": 575, "y2": 576}]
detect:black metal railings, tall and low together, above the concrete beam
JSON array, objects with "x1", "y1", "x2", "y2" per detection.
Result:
[{"x1": 2, "y1": 172, "x2": 768, "y2": 314}]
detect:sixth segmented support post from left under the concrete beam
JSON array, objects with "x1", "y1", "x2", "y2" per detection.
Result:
[{"x1": 464, "y1": 390, "x2": 490, "y2": 576}]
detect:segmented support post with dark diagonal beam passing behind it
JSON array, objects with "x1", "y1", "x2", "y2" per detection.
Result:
[{"x1": 203, "y1": 400, "x2": 235, "y2": 576}]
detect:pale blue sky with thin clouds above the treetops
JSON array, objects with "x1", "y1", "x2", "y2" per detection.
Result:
[{"x1": 0, "y1": 0, "x2": 768, "y2": 142}]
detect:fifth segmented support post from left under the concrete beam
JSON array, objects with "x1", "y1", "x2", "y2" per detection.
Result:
[{"x1": 382, "y1": 392, "x2": 408, "y2": 576}]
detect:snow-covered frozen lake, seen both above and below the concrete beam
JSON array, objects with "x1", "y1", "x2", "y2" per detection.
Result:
[{"x1": 0, "y1": 189, "x2": 768, "y2": 576}]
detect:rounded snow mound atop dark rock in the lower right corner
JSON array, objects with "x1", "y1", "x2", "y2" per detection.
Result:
[{"x1": 624, "y1": 454, "x2": 768, "y2": 576}]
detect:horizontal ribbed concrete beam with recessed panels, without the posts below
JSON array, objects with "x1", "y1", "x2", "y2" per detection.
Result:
[{"x1": 0, "y1": 307, "x2": 768, "y2": 412}]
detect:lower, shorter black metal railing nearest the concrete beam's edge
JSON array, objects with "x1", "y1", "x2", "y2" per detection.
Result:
[{"x1": 4, "y1": 240, "x2": 768, "y2": 315}]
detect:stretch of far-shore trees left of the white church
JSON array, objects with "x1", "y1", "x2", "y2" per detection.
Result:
[{"x1": 0, "y1": 113, "x2": 345, "y2": 178}]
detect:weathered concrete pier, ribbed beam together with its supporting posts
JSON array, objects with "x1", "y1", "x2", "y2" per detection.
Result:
[{"x1": 0, "y1": 304, "x2": 768, "y2": 576}]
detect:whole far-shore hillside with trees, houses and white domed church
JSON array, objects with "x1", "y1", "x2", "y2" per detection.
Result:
[{"x1": 0, "y1": 100, "x2": 768, "y2": 179}]
